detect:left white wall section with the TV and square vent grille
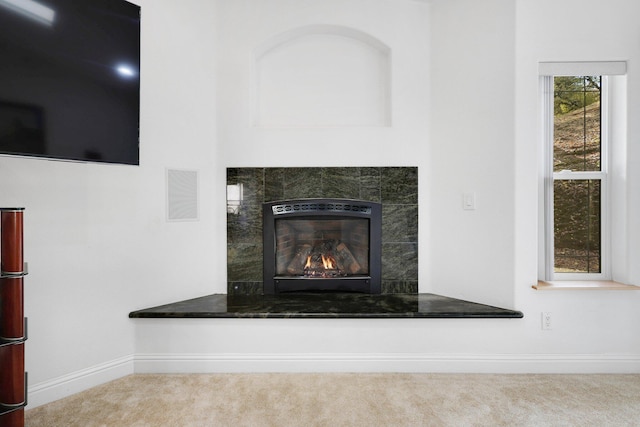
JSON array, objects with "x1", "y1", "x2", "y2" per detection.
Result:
[{"x1": 0, "y1": 0, "x2": 220, "y2": 406}]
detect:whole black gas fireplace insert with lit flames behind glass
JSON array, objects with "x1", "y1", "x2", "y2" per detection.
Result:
[{"x1": 262, "y1": 199, "x2": 382, "y2": 294}]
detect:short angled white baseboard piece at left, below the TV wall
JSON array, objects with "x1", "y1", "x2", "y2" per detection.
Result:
[{"x1": 26, "y1": 355, "x2": 134, "y2": 410}]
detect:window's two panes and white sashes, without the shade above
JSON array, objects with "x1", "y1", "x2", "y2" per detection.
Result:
[{"x1": 545, "y1": 76, "x2": 609, "y2": 280}]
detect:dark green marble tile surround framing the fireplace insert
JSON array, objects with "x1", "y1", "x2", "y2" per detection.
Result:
[{"x1": 227, "y1": 167, "x2": 418, "y2": 295}]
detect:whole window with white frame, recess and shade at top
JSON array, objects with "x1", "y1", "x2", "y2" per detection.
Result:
[{"x1": 538, "y1": 61, "x2": 630, "y2": 288}]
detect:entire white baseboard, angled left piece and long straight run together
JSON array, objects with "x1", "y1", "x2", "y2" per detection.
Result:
[{"x1": 27, "y1": 353, "x2": 640, "y2": 409}]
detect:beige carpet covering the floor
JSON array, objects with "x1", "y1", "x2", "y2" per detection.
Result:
[{"x1": 25, "y1": 374, "x2": 640, "y2": 427}]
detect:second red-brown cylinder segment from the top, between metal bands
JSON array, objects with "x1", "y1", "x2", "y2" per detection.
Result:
[{"x1": 0, "y1": 277, "x2": 24, "y2": 340}]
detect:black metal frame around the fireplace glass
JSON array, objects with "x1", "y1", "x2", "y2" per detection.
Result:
[{"x1": 262, "y1": 198, "x2": 382, "y2": 294}]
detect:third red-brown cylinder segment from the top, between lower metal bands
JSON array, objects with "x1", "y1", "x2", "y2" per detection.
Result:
[{"x1": 0, "y1": 343, "x2": 25, "y2": 405}]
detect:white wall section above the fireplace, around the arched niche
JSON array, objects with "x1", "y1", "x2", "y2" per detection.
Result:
[{"x1": 216, "y1": 0, "x2": 429, "y2": 171}]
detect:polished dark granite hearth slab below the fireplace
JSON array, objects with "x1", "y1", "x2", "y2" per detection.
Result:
[{"x1": 129, "y1": 293, "x2": 523, "y2": 319}]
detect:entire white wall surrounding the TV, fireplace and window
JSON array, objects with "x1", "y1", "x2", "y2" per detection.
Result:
[{"x1": 0, "y1": 0, "x2": 640, "y2": 412}]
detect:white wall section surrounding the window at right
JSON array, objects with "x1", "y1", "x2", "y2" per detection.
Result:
[{"x1": 514, "y1": 0, "x2": 640, "y2": 371}]
